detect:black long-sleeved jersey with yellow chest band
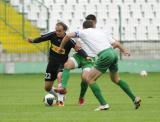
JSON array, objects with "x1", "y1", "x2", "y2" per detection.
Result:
[{"x1": 33, "y1": 32, "x2": 75, "y2": 63}]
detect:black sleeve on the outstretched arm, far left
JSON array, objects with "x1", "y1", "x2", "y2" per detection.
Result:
[{"x1": 33, "y1": 32, "x2": 54, "y2": 43}]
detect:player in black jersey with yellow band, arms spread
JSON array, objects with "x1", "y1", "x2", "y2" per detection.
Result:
[{"x1": 28, "y1": 22, "x2": 87, "y2": 106}]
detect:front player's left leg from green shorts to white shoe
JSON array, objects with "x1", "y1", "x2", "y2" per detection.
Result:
[{"x1": 87, "y1": 48, "x2": 118, "y2": 110}]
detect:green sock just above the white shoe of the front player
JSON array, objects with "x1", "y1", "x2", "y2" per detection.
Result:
[{"x1": 89, "y1": 83, "x2": 107, "y2": 105}]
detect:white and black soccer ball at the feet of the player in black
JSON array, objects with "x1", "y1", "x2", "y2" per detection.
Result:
[{"x1": 44, "y1": 94, "x2": 57, "y2": 106}]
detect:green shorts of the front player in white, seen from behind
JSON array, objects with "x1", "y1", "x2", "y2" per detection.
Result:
[{"x1": 95, "y1": 48, "x2": 118, "y2": 73}]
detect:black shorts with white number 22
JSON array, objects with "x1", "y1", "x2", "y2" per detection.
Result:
[{"x1": 45, "y1": 61, "x2": 64, "y2": 82}]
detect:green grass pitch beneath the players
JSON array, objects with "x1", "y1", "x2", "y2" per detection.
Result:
[{"x1": 0, "y1": 73, "x2": 160, "y2": 122}]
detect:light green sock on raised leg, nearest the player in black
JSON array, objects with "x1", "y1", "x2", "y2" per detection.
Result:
[{"x1": 62, "y1": 69, "x2": 70, "y2": 88}]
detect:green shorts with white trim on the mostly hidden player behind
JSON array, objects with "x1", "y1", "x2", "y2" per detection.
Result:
[{"x1": 70, "y1": 53, "x2": 94, "y2": 70}]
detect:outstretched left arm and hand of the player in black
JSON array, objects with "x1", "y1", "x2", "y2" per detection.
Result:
[{"x1": 28, "y1": 32, "x2": 53, "y2": 43}]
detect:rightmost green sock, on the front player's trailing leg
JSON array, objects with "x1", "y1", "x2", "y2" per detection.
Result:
[{"x1": 118, "y1": 80, "x2": 135, "y2": 101}]
